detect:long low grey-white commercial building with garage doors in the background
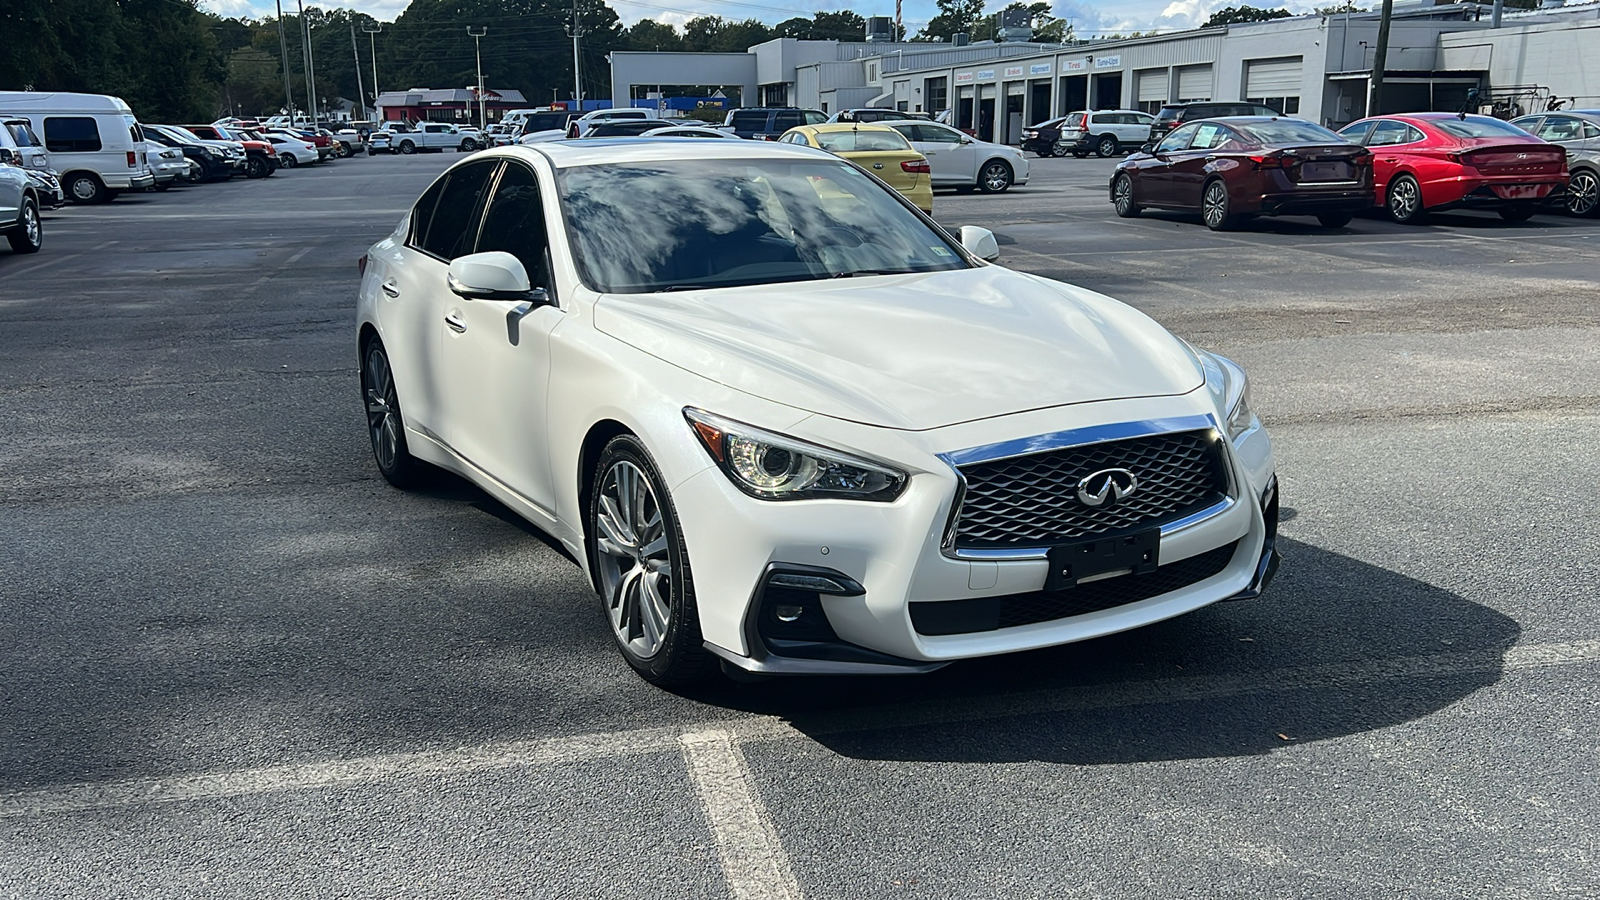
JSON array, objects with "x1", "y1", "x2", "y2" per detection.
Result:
[{"x1": 611, "y1": 0, "x2": 1600, "y2": 143}]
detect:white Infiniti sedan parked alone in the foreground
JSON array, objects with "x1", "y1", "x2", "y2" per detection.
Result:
[{"x1": 355, "y1": 139, "x2": 1278, "y2": 684}]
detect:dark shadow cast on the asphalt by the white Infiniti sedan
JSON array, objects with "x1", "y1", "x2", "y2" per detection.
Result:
[{"x1": 684, "y1": 541, "x2": 1520, "y2": 765}]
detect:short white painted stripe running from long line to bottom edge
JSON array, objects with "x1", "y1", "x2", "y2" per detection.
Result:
[{"x1": 678, "y1": 729, "x2": 802, "y2": 900}]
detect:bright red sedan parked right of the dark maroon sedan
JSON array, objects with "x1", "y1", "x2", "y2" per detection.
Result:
[{"x1": 1339, "y1": 112, "x2": 1566, "y2": 223}]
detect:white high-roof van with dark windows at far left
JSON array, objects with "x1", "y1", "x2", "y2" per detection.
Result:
[{"x1": 0, "y1": 91, "x2": 155, "y2": 203}]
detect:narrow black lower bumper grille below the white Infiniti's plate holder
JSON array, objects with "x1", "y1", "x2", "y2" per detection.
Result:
[{"x1": 910, "y1": 541, "x2": 1238, "y2": 636}]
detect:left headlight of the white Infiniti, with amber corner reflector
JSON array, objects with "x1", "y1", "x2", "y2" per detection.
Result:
[{"x1": 683, "y1": 408, "x2": 906, "y2": 503}]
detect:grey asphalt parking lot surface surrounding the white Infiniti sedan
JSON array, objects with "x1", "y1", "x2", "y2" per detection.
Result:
[{"x1": 0, "y1": 154, "x2": 1600, "y2": 898}]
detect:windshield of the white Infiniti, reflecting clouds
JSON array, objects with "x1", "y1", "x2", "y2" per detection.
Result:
[{"x1": 557, "y1": 159, "x2": 968, "y2": 293}]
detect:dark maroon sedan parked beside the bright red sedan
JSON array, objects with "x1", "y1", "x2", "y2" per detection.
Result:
[{"x1": 1110, "y1": 115, "x2": 1373, "y2": 231}]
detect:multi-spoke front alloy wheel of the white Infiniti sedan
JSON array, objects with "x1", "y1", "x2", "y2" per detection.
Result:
[{"x1": 595, "y1": 460, "x2": 672, "y2": 660}]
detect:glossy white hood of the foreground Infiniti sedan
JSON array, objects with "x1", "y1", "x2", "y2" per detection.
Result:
[{"x1": 595, "y1": 266, "x2": 1203, "y2": 431}]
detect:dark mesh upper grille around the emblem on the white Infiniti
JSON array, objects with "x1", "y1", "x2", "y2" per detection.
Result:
[{"x1": 955, "y1": 429, "x2": 1227, "y2": 549}]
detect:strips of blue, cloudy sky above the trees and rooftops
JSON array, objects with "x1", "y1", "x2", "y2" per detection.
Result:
[{"x1": 202, "y1": 0, "x2": 1331, "y2": 37}]
